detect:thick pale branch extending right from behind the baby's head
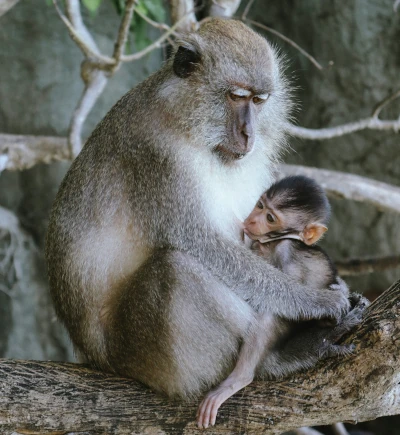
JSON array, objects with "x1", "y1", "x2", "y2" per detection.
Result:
[{"x1": 278, "y1": 165, "x2": 400, "y2": 213}]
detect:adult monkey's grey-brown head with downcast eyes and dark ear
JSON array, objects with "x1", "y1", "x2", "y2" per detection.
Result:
[{"x1": 163, "y1": 19, "x2": 290, "y2": 162}]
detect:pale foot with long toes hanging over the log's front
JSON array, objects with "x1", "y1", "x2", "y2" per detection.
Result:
[{"x1": 196, "y1": 377, "x2": 252, "y2": 429}]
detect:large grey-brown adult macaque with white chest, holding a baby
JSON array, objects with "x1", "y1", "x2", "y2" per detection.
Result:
[{"x1": 47, "y1": 19, "x2": 349, "y2": 404}]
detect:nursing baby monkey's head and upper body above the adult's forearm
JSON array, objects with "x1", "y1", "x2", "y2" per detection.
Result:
[{"x1": 245, "y1": 175, "x2": 345, "y2": 290}]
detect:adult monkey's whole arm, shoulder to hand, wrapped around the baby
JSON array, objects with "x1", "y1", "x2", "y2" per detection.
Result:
[{"x1": 129, "y1": 149, "x2": 349, "y2": 319}]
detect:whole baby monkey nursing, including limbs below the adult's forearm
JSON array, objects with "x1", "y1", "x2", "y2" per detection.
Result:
[{"x1": 197, "y1": 176, "x2": 351, "y2": 427}]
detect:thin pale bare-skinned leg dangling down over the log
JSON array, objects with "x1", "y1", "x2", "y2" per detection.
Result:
[{"x1": 197, "y1": 314, "x2": 287, "y2": 428}]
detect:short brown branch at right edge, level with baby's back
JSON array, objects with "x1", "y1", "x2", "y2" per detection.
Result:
[{"x1": 335, "y1": 255, "x2": 400, "y2": 276}]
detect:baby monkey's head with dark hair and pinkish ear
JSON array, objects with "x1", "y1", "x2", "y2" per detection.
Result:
[{"x1": 244, "y1": 175, "x2": 330, "y2": 245}]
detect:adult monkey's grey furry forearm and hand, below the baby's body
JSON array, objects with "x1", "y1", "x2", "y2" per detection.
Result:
[{"x1": 181, "y1": 233, "x2": 349, "y2": 319}]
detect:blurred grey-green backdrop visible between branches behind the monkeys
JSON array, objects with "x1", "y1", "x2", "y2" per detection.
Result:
[{"x1": 0, "y1": 0, "x2": 400, "y2": 435}]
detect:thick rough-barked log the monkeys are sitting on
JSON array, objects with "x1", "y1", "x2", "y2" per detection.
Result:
[{"x1": 0, "y1": 280, "x2": 400, "y2": 435}]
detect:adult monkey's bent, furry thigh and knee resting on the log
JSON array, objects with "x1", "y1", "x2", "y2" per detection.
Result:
[{"x1": 105, "y1": 250, "x2": 254, "y2": 397}]
